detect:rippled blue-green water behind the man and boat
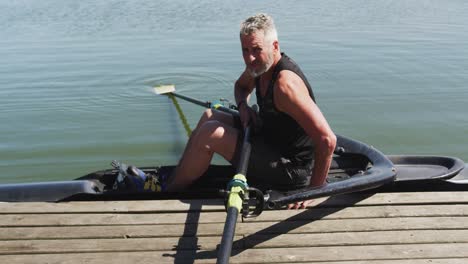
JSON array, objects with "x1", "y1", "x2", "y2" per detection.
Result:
[{"x1": 0, "y1": 0, "x2": 468, "y2": 182}]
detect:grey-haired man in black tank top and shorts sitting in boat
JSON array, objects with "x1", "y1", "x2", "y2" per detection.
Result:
[{"x1": 166, "y1": 14, "x2": 336, "y2": 209}]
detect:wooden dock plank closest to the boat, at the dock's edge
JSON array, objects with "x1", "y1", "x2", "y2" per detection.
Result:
[{"x1": 0, "y1": 192, "x2": 468, "y2": 214}]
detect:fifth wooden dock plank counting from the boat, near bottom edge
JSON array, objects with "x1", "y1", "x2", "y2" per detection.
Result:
[{"x1": 0, "y1": 243, "x2": 468, "y2": 264}]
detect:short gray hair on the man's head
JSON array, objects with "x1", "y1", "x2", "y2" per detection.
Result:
[{"x1": 240, "y1": 13, "x2": 278, "y2": 42}]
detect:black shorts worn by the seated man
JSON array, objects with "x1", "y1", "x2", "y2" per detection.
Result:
[{"x1": 232, "y1": 117, "x2": 313, "y2": 190}]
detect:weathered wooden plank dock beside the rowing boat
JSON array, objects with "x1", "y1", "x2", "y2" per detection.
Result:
[{"x1": 0, "y1": 192, "x2": 468, "y2": 264}]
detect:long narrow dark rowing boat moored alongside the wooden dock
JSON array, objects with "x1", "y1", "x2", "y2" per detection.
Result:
[{"x1": 0, "y1": 136, "x2": 468, "y2": 209}]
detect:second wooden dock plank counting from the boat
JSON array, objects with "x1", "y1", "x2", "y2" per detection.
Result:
[{"x1": 0, "y1": 204, "x2": 468, "y2": 227}]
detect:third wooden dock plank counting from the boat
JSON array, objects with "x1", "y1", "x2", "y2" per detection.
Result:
[{"x1": 0, "y1": 217, "x2": 468, "y2": 240}]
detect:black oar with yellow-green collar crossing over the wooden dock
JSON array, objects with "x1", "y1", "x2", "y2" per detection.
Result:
[{"x1": 216, "y1": 126, "x2": 250, "y2": 264}]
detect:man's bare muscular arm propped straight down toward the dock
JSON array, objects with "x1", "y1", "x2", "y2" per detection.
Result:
[{"x1": 274, "y1": 71, "x2": 336, "y2": 186}]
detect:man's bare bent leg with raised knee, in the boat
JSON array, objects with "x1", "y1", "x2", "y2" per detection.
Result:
[{"x1": 167, "y1": 110, "x2": 239, "y2": 191}]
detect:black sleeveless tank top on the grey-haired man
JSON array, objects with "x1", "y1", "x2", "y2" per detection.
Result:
[{"x1": 255, "y1": 53, "x2": 315, "y2": 164}]
